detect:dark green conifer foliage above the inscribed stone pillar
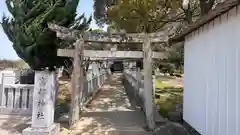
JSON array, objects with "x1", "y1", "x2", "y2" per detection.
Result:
[{"x1": 1, "y1": 0, "x2": 91, "y2": 70}]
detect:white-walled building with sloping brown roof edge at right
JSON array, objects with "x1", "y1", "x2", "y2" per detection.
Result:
[{"x1": 175, "y1": 0, "x2": 240, "y2": 135}]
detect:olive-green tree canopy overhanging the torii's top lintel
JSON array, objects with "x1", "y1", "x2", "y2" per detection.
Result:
[{"x1": 94, "y1": 0, "x2": 218, "y2": 29}]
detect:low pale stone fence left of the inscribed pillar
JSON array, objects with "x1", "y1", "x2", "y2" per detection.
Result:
[{"x1": 0, "y1": 84, "x2": 34, "y2": 116}]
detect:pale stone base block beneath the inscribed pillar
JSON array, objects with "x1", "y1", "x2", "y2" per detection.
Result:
[{"x1": 22, "y1": 124, "x2": 60, "y2": 135}]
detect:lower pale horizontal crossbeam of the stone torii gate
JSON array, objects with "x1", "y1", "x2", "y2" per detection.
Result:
[{"x1": 58, "y1": 49, "x2": 166, "y2": 59}]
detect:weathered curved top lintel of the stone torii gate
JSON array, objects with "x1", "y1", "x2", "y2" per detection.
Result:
[{"x1": 48, "y1": 24, "x2": 168, "y2": 44}]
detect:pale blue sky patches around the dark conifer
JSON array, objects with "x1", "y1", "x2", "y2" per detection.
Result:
[{"x1": 0, "y1": 0, "x2": 102, "y2": 60}]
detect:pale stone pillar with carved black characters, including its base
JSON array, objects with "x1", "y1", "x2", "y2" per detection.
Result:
[{"x1": 23, "y1": 71, "x2": 60, "y2": 135}]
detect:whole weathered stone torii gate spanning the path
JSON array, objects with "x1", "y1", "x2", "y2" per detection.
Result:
[{"x1": 49, "y1": 24, "x2": 168, "y2": 130}]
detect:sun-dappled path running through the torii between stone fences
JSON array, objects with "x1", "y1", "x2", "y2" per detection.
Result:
[{"x1": 71, "y1": 74, "x2": 152, "y2": 135}]
